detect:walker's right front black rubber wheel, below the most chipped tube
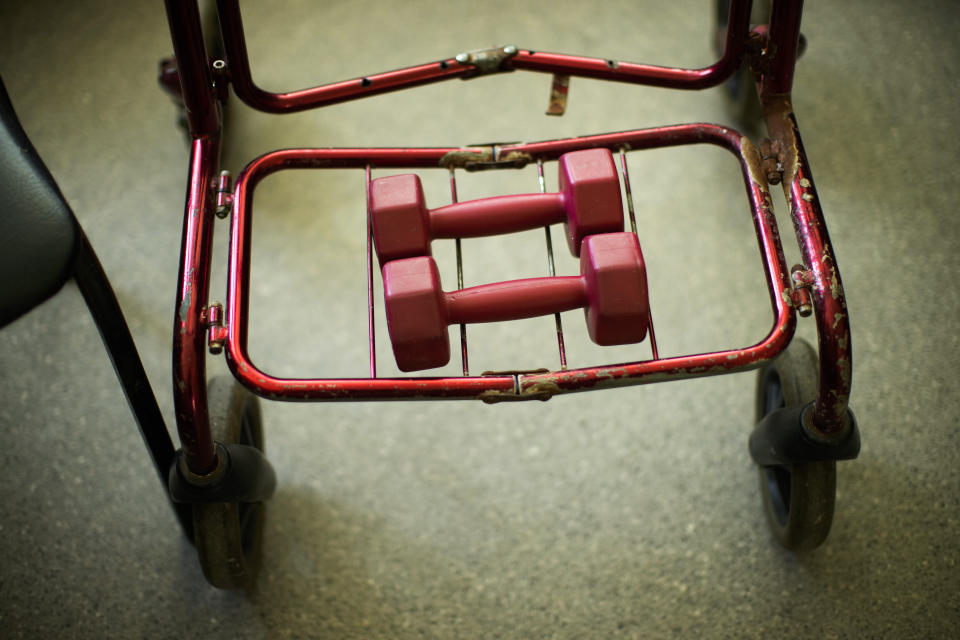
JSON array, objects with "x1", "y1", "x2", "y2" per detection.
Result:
[{"x1": 756, "y1": 338, "x2": 837, "y2": 551}]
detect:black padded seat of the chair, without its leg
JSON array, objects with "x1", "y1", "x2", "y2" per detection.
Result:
[{"x1": 0, "y1": 78, "x2": 80, "y2": 327}]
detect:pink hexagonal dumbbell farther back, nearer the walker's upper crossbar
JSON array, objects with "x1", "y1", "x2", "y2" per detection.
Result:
[{"x1": 370, "y1": 149, "x2": 623, "y2": 267}]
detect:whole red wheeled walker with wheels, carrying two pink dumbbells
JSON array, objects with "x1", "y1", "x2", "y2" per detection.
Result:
[{"x1": 0, "y1": 0, "x2": 860, "y2": 588}]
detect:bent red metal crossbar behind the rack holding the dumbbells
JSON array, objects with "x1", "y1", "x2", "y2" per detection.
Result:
[{"x1": 218, "y1": 0, "x2": 750, "y2": 113}]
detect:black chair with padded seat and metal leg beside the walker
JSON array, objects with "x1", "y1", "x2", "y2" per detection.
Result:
[{"x1": 0, "y1": 78, "x2": 193, "y2": 539}]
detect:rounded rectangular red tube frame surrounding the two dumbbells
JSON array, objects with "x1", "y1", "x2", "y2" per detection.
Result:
[{"x1": 226, "y1": 124, "x2": 795, "y2": 401}]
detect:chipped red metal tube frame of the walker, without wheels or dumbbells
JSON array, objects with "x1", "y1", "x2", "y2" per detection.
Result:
[{"x1": 166, "y1": 0, "x2": 852, "y2": 488}]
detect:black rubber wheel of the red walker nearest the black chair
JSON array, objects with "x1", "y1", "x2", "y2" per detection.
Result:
[{"x1": 193, "y1": 376, "x2": 265, "y2": 589}]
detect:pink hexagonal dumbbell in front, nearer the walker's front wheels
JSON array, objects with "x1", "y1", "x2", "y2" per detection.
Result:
[{"x1": 383, "y1": 232, "x2": 649, "y2": 371}]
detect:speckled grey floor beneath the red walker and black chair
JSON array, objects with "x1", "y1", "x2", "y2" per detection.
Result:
[{"x1": 0, "y1": 0, "x2": 960, "y2": 638}]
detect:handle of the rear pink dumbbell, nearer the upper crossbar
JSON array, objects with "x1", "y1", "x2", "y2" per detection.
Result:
[{"x1": 428, "y1": 193, "x2": 567, "y2": 238}]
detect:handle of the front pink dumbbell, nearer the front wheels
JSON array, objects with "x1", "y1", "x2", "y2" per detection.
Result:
[{"x1": 443, "y1": 276, "x2": 588, "y2": 324}]
